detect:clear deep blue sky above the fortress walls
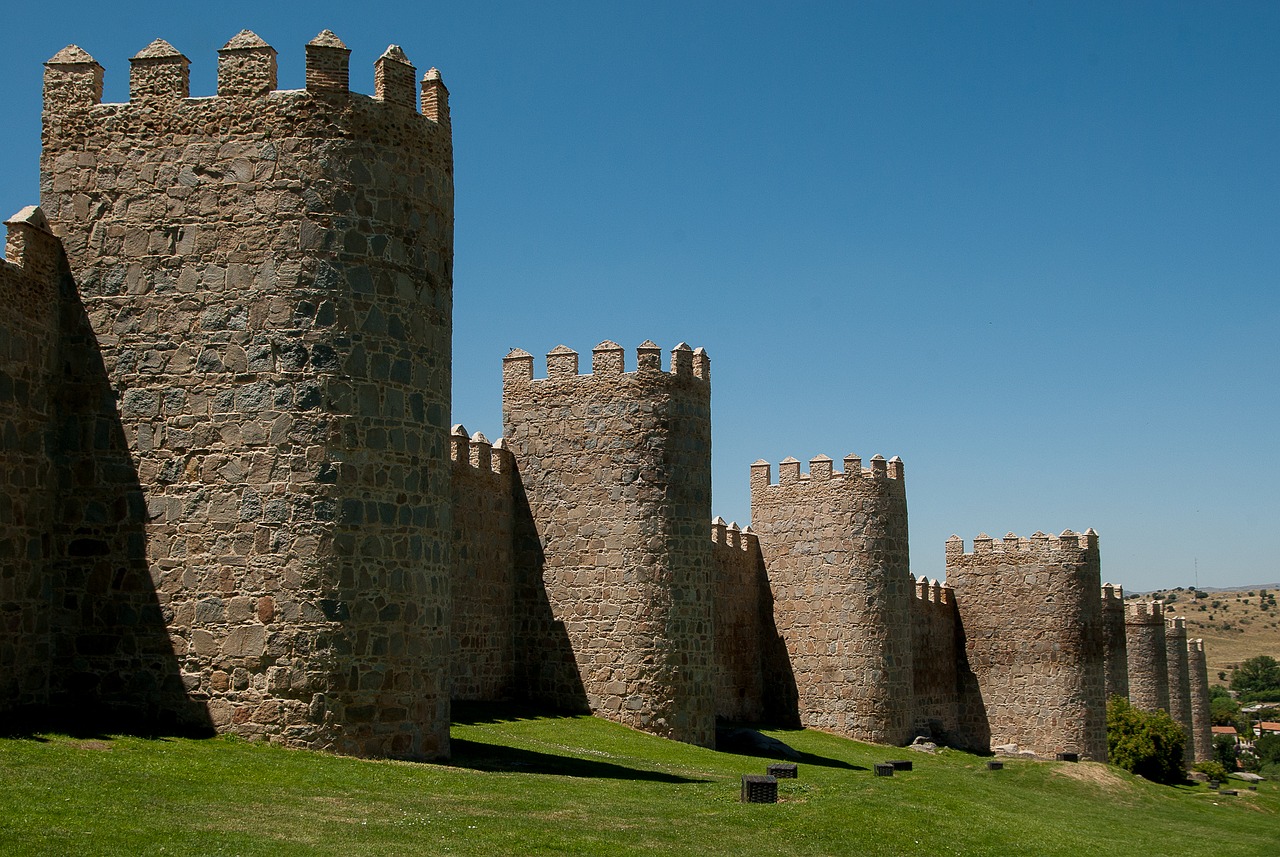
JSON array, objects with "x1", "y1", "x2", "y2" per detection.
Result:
[{"x1": 0, "y1": 1, "x2": 1280, "y2": 590}]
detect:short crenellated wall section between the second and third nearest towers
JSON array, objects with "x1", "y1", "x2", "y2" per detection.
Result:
[{"x1": 712, "y1": 518, "x2": 772, "y2": 723}]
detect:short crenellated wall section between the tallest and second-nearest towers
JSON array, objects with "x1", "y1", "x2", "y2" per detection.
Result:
[{"x1": 449, "y1": 426, "x2": 516, "y2": 700}]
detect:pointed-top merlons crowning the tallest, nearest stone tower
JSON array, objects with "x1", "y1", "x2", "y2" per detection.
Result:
[{"x1": 45, "y1": 29, "x2": 449, "y2": 125}]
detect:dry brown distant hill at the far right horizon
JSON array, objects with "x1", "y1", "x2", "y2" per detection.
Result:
[{"x1": 1126, "y1": 583, "x2": 1280, "y2": 684}]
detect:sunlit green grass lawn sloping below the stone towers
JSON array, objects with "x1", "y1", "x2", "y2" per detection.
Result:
[{"x1": 0, "y1": 709, "x2": 1280, "y2": 857}]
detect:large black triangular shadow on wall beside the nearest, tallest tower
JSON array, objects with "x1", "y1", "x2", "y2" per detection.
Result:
[{"x1": 38, "y1": 272, "x2": 214, "y2": 735}]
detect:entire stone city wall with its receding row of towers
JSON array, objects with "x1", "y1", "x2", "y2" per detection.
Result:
[{"x1": 0, "y1": 31, "x2": 1208, "y2": 759}]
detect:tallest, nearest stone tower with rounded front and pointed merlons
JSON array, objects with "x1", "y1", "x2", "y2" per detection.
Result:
[{"x1": 41, "y1": 31, "x2": 453, "y2": 757}]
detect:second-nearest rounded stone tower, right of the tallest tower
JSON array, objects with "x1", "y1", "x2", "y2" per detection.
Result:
[{"x1": 503, "y1": 342, "x2": 716, "y2": 746}]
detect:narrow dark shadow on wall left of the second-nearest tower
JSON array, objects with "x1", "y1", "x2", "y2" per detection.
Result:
[{"x1": 512, "y1": 467, "x2": 590, "y2": 714}]
